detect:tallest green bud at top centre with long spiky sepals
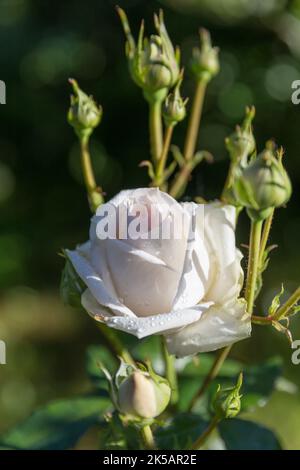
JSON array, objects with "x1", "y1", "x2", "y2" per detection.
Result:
[{"x1": 117, "y1": 7, "x2": 180, "y2": 101}]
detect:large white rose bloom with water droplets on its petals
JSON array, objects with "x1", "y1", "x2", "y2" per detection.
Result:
[{"x1": 67, "y1": 188, "x2": 251, "y2": 357}]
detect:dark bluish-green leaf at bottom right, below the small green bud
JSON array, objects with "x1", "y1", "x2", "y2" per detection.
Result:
[{"x1": 219, "y1": 419, "x2": 281, "y2": 450}]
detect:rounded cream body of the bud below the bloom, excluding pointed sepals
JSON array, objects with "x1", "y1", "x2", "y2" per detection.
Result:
[{"x1": 118, "y1": 370, "x2": 171, "y2": 418}]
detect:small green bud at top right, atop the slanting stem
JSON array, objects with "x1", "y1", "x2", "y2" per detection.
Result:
[{"x1": 190, "y1": 28, "x2": 220, "y2": 82}]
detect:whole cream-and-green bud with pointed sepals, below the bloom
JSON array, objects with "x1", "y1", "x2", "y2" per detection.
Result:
[{"x1": 101, "y1": 360, "x2": 171, "y2": 425}]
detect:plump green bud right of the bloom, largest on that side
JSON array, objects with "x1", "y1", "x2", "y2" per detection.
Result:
[{"x1": 233, "y1": 149, "x2": 292, "y2": 220}]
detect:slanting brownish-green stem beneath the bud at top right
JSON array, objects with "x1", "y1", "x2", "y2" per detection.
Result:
[{"x1": 183, "y1": 80, "x2": 207, "y2": 161}]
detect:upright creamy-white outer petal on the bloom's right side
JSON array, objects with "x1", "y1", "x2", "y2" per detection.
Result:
[{"x1": 204, "y1": 203, "x2": 243, "y2": 304}]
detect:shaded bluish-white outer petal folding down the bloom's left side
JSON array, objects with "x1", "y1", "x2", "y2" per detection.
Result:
[{"x1": 67, "y1": 244, "x2": 134, "y2": 316}]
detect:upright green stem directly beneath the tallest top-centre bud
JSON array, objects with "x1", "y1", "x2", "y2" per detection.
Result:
[{"x1": 149, "y1": 99, "x2": 163, "y2": 163}]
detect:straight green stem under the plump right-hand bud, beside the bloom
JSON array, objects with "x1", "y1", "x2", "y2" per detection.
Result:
[{"x1": 245, "y1": 220, "x2": 263, "y2": 315}]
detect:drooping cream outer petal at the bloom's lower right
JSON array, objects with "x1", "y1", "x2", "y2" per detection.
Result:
[{"x1": 166, "y1": 300, "x2": 251, "y2": 357}]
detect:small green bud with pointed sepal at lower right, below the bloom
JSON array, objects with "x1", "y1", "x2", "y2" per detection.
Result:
[{"x1": 213, "y1": 373, "x2": 243, "y2": 420}]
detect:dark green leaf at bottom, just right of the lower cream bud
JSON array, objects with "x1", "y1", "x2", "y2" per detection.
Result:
[{"x1": 155, "y1": 413, "x2": 208, "y2": 450}]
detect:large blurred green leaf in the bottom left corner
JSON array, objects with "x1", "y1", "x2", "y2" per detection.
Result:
[{"x1": 0, "y1": 396, "x2": 110, "y2": 450}]
